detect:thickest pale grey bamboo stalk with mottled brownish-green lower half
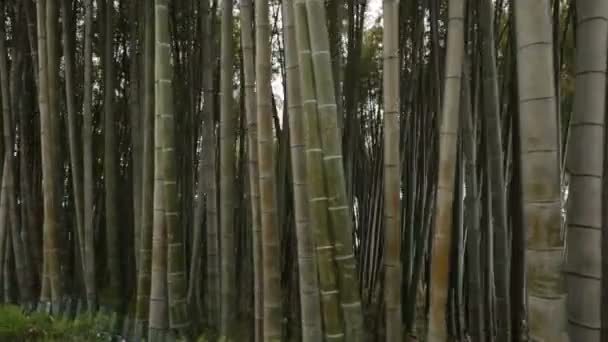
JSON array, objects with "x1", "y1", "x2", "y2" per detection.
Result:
[{"x1": 514, "y1": 0, "x2": 569, "y2": 341}]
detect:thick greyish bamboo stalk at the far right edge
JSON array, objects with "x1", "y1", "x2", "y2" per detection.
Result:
[{"x1": 566, "y1": 0, "x2": 608, "y2": 342}]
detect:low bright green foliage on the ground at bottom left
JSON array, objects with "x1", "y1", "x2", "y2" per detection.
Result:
[{"x1": 0, "y1": 306, "x2": 109, "y2": 342}]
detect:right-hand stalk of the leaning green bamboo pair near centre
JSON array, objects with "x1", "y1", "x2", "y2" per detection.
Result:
[{"x1": 306, "y1": 0, "x2": 364, "y2": 342}]
